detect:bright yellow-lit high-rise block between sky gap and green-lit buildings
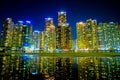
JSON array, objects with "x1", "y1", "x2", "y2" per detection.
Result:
[{"x1": 76, "y1": 19, "x2": 98, "y2": 51}]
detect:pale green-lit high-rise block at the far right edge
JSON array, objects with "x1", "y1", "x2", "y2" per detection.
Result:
[{"x1": 98, "y1": 22, "x2": 120, "y2": 50}]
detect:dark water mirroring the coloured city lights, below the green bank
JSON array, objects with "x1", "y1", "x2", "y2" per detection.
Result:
[{"x1": 0, "y1": 54, "x2": 120, "y2": 80}]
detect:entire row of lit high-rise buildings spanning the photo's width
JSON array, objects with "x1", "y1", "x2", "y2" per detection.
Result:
[{"x1": 0, "y1": 11, "x2": 120, "y2": 53}]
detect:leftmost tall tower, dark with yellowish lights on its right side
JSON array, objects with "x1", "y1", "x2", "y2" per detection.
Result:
[{"x1": 0, "y1": 18, "x2": 14, "y2": 49}]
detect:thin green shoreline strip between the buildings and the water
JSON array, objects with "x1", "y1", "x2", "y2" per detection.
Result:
[{"x1": 0, "y1": 52, "x2": 120, "y2": 57}]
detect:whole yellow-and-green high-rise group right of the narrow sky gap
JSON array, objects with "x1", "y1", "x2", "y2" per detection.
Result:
[{"x1": 76, "y1": 19, "x2": 120, "y2": 51}]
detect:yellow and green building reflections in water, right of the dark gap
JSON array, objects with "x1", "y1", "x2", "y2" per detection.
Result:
[{"x1": 78, "y1": 57, "x2": 120, "y2": 80}]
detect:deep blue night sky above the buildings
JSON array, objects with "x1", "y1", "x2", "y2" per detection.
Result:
[{"x1": 0, "y1": 0, "x2": 120, "y2": 39}]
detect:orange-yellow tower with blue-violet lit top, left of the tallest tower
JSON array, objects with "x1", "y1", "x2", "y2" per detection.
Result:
[{"x1": 44, "y1": 18, "x2": 56, "y2": 52}]
